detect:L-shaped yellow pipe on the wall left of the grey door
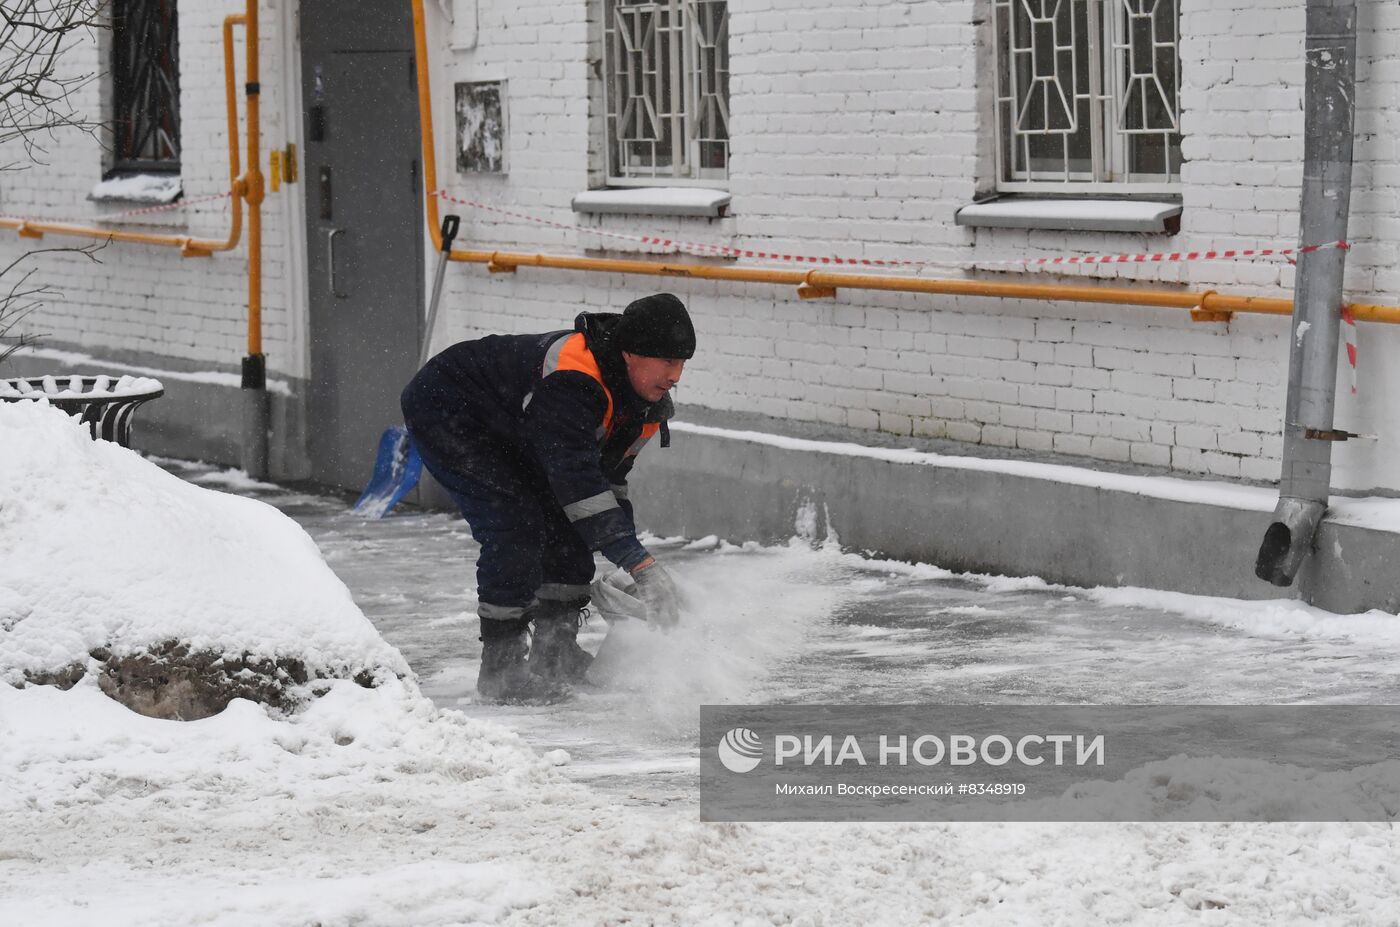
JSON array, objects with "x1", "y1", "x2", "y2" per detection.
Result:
[{"x1": 0, "y1": 8, "x2": 249, "y2": 258}]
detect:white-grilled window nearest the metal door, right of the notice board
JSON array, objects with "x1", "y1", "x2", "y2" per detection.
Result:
[{"x1": 603, "y1": 0, "x2": 729, "y2": 186}]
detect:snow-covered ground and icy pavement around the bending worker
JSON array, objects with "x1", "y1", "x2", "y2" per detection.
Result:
[{"x1": 0, "y1": 419, "x2": 1400, "y2": 927}]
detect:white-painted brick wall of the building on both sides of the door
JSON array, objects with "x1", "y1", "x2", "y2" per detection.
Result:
[{"x1": 0, "y1": 0, "x2": 1400, "y2": 489}]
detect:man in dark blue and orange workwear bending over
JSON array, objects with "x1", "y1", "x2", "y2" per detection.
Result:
[{"x1": 402, "y1": 293, "x2": 696, "y2": 702}]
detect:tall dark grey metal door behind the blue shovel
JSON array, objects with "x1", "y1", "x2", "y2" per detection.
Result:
[{"x1": 301, "y1": 0, "x2": 423, "y2": 489}]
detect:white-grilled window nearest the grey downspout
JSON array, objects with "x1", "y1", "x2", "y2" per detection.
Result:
[{"x1": 993, "y1": 0, "x2": 1182, "y2": 193}]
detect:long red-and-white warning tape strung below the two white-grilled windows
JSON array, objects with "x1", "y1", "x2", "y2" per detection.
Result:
[{"x1": 433, "y1": 190, "x2": 1350, "y2": 267}]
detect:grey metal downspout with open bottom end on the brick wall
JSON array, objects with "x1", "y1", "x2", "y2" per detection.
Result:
[{"x1": 1254, "y1": 0, "x2": 1357, "y2": 585}]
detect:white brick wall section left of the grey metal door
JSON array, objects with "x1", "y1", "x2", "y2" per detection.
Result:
[{"x1": 0, "y1": 0, "x2": 304, "y2": 375}]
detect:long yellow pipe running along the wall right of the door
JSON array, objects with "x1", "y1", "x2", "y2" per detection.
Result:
[{"x1": 412, "y1": 0, "x2": 1400, "y2": 323}]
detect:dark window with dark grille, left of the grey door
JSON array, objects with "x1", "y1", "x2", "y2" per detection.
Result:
[{"x1": 112, "y1": 0, "x2": 179, "y2": 171}]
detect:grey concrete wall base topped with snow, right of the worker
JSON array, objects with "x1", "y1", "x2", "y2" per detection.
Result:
[{"x1": 631, "y1": 423, "x2": 1400, "y2": 612}]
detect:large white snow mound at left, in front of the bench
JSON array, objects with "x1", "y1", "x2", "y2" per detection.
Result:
[{"x1": 0, "y1": 402, "x2": 407, "y2": 694}]
